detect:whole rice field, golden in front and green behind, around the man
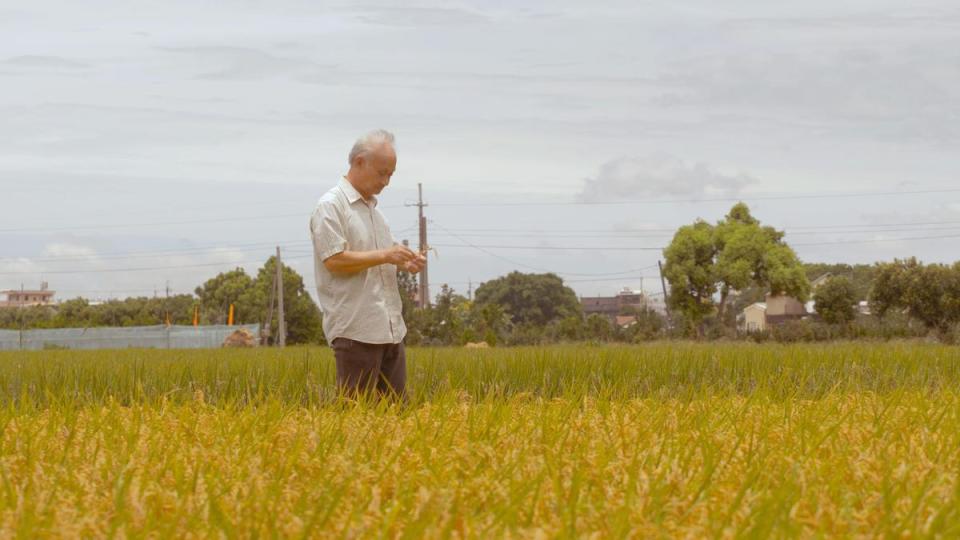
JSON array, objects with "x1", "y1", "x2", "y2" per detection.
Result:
[{"x1": 0, "y1": 343, "x2": 960, "y2": 538}]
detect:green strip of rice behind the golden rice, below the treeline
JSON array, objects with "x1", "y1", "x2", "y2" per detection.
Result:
[{"x1": 0, "y1": 343, "x2": 960, "y2": 406}]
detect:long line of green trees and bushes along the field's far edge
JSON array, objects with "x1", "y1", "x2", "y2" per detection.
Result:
[{"x1": 7, "y1": 209, "x2": 960, "y2": 346}]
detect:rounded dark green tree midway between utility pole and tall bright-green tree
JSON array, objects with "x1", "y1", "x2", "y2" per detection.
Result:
[{"x1": 475, "y1": 272, "x2": 582, "y2": 326}]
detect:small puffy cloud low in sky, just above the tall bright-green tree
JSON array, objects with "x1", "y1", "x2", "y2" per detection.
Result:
[{"x1": 579, "y1": 154, "x2": 755, "y2": 202}]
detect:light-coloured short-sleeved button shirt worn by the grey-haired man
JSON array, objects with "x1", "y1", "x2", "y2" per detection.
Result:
[{"x1": 310, "y1": 178, "x2": 407, "y2": 344}]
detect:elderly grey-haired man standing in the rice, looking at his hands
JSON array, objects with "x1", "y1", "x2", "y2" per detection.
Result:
[{"x1": 310, "y1": 130, "x2": 426, "y2": 397}]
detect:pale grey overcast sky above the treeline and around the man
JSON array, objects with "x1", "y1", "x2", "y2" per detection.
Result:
[{"x1": 0, "y1": 0, "x2": 960, "y2": 304}]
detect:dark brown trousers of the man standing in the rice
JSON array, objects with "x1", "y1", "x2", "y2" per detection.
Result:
[{"x1": 330, "y1": 337, "x2": 407, "y2": 399}]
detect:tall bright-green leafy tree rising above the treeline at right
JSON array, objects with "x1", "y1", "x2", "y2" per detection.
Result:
[{"x1": 664, "y1": 203, "x2": 810, "y2": 331}]
